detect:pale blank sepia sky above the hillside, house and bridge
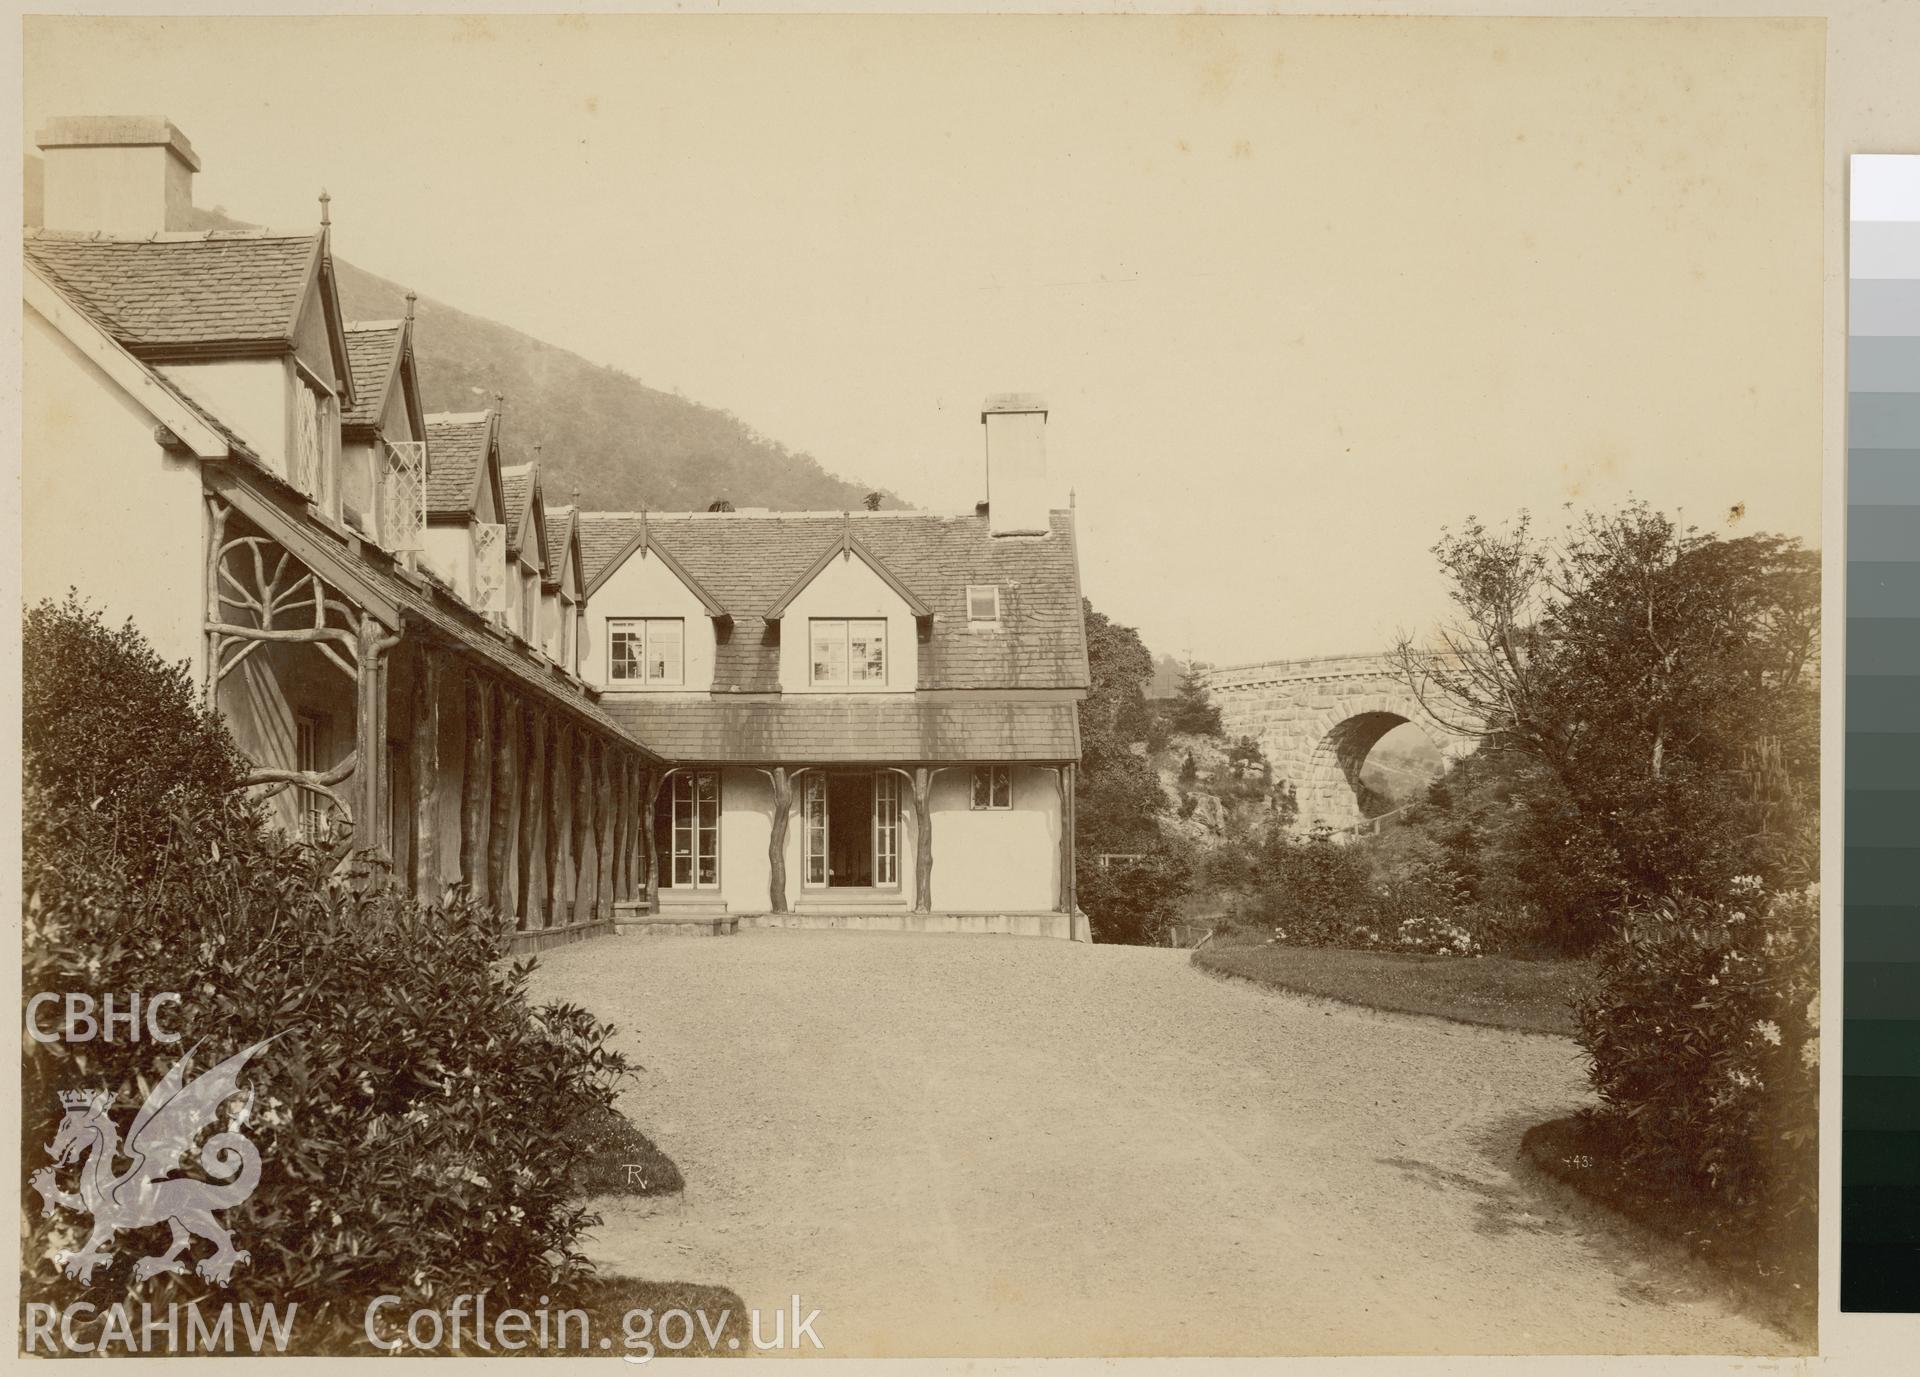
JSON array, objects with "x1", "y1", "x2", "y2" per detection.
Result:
[{"x1": 25, "y1": 17, "x2": 1822, "y2": 664}]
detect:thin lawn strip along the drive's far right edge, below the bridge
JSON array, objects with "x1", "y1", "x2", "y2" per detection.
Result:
[{"x1": 1194, "y1": 945, "x2": 1590, "y2": 1037}]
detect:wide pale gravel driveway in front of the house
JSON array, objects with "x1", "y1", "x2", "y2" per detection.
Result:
[{"x1": 522, "y1": 930, "x2": 1786, "y2": 1356}]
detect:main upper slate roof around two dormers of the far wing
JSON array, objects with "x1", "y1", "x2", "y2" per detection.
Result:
[{"x1": 580, "y1": 511, "x2": 1089, "y2": 693}]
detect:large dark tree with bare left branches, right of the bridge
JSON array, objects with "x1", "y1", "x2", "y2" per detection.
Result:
[{"x1": 1398, "y1": 503, "x2": 1818, "y2": 935}]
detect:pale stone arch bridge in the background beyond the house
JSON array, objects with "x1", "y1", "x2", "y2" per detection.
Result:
[{"x1": 1204, "y1": 655, "x2": 1476, "y2": 832}]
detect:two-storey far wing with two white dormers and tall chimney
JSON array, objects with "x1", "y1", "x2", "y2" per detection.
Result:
[{"x1": 580, "y1": 396, "x2": 1089, "y2": 937}]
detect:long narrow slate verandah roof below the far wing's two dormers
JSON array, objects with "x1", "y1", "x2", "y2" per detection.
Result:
[{"x1": 601, "y1": 693, "x2": 1079, "y2": 764}]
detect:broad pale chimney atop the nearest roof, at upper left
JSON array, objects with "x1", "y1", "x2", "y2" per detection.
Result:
[{"x1": 35, "y1": 115, "x2": 200, "y2": 234}]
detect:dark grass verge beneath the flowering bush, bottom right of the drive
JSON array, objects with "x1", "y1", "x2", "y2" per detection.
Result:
[{"x1": 1521, "y1": 1114, "x2": 1820, "y2": 1348}]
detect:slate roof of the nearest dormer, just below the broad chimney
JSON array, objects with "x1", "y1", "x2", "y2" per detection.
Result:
[{"x1": 23, "y1": 230, "x2": 321, "y2": 353}]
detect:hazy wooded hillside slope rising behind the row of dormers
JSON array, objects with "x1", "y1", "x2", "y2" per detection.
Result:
[{"x1": 25, "y1": 174, "x2": 904, "y2": 511}]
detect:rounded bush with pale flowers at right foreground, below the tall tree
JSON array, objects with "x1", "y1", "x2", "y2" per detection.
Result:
[{"x1": 1580, "y1": 876, "x2": 1820, "y2": 1244}]
